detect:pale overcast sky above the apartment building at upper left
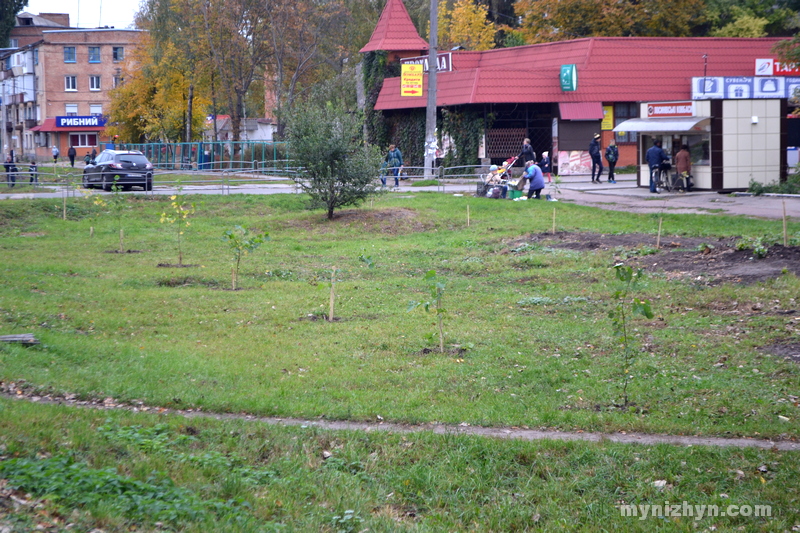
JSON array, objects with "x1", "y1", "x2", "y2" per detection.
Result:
[{"x1": 23, "y1": 0, "x2": 139, "y2": 29}]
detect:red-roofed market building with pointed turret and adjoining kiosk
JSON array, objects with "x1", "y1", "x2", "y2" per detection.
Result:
[{"x1": 362, "y1": 0, "x2": 800, "y2": 190}]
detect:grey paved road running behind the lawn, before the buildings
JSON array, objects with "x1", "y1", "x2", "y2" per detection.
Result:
[{"x1": 0, "y1": 171, "x2": 800, "y2": 220}]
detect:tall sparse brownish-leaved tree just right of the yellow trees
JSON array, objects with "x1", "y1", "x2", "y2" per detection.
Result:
[{"x1": 200, "y1": 0, "x2": 274, "y2": 154}]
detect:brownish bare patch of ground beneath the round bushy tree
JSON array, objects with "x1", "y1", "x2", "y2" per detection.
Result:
[{"x1": 288, "y1": 206, "x2": 433, "y2": 235}]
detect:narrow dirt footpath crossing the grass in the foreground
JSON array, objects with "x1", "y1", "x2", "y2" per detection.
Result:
[{"x1": 0, "y1": 390, "x2": 800, "y2": 451}]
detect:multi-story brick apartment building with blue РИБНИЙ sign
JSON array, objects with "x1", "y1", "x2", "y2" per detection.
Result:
[{"x1": 0, "y1": 14, "x2": 140, "y2": 164}]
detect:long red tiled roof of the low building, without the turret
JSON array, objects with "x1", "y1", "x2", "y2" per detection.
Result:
[{"x1": 375, "y1": 37, "x2": 780, "y2": 110}]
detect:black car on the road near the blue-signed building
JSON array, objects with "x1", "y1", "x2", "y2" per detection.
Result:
[{"x1": 83, "y1": 150, "x2": 153, "y2": 191}]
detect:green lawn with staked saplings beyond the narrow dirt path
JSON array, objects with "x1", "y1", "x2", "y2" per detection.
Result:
[{"x1": 0, "y1": 193, "x2": 800, "y2": 437}]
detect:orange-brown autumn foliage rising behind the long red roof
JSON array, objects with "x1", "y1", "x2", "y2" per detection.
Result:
[{"x1": 514, "y1": 0, "x2": 705, "y2": 43}]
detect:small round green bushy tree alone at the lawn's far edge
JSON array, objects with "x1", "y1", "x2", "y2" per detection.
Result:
[{"x1": 288, "y1": 102, "x2": 381, "y2": 220}]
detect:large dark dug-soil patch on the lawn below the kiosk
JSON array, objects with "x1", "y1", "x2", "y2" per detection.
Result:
[{"x1": 511, "y1": 232, "x2": 800, "y2": 283}]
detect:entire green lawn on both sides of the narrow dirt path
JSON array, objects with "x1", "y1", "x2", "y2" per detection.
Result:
[{"x1": 0, "y1": 193, "x2": 800, "y2": 531}]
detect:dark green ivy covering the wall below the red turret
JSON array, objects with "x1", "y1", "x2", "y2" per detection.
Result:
[{"x1": 362, "y1": 52, "x2": 489, "y2": 167}]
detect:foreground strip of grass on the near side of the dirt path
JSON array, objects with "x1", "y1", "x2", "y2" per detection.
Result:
[{"x1": 0, "y1": 400, "x2": 800, "y2": 532}]
